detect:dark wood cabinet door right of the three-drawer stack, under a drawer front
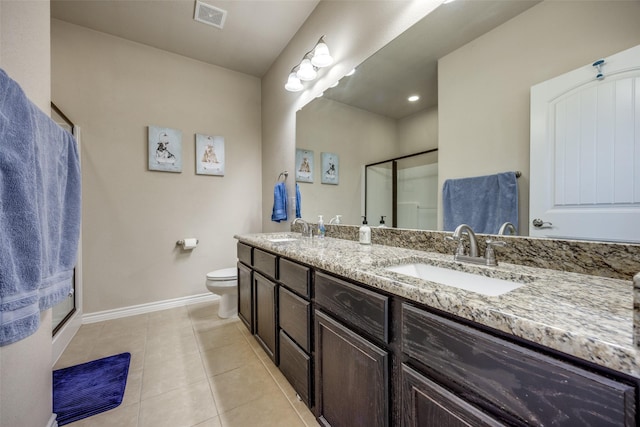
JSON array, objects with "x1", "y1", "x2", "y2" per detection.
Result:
[{"x1": 315, "y1": 311, "x2": 389, "y2": 427}]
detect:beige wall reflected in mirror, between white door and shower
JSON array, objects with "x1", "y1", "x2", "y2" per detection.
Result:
[{"x1": 438, "y1": 1, "x2": 640, "y2": 234}]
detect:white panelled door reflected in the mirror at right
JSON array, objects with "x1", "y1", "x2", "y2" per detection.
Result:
[{"x1": 529, "y1": 46, "x2": 640, "y2": 242}]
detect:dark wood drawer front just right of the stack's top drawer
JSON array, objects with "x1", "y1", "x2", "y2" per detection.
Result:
[{"x1": 315, "y1": 273, "x2": 389, "y2": 343}]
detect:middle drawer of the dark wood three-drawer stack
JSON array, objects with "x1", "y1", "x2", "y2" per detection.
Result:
[{"x1": 278, "y1": 287, "x2": 311, "y2": 353}]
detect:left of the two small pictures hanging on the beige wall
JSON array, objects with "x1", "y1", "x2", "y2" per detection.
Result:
[{"x1": 148, "y1": 125, "x2": 182, "y2": 173}]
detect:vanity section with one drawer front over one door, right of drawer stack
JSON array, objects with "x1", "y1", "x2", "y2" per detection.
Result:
[{"x1": 315, "y1": 272, "x2": 391, "y2": 427}]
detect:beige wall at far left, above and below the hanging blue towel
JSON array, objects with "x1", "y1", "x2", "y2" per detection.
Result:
[{"x1": 0, "y1": 0, "x2": 52, "y2": 427}]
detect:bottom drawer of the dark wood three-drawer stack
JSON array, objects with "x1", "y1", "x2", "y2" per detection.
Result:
[{"x1": 279, "y1": 331, "x2": 312, "y2": 407}]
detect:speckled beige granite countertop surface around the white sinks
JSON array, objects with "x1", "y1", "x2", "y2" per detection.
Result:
[{"x1": 235, "y1": 233, "x2": 640, "y2": 378}]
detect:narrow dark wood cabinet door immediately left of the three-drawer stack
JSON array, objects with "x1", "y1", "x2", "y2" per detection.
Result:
[{"x1": 253, "y1": 272, "x2": 278, "y2": 365}]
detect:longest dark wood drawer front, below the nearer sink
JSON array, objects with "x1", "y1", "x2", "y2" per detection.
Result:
[{"x1": 402, "y1": 304, "x2": 636, "y2": 426}]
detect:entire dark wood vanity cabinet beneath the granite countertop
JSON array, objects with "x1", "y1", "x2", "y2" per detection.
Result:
[{"x1": 239, "y1": 242, "x2": 640, "y2": 427}]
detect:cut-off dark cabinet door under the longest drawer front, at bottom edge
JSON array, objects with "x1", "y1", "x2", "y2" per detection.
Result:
[{"x1": 402, "y1": 365, "x2": 504, "y2": 427}]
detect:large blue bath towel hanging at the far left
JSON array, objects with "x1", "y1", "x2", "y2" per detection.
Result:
[{"x1": 0, "y1": 69, "x2": 80, "y2": 346}]
